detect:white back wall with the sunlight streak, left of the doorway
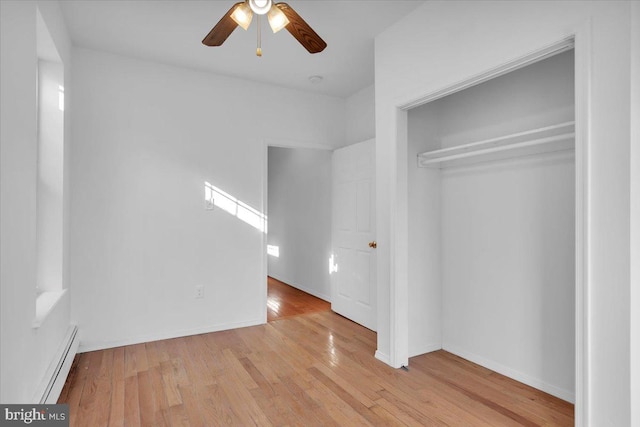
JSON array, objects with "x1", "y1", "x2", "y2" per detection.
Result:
[{"x1": 71, "y1": 49, "x2": 344, "y2": 350}]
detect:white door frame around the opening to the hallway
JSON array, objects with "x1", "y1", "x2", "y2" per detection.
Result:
[{"x1": 260, "y1": 138, "x2": 336, "y2": 323}]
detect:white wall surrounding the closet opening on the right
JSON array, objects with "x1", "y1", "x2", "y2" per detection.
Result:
[{"x1": 375, "y1": 1, "x2": 639, "y2": 425}]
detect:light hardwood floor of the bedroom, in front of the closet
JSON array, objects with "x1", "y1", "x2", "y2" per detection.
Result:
[{"x1": 59, "y1": 311, "x2": 573, "y2": 427}]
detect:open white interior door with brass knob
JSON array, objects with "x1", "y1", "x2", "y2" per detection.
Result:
[{"x1": 331, "y1": 140, "x2": 376, "y2": 331}]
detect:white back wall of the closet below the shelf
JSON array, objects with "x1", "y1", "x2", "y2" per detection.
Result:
[{"x1": 442, "y1": 155, "x2": 575, "y2": 401}]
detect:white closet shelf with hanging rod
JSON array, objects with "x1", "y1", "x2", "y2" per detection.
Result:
[{"x1": 418, "y1": 121, "x2": 575, "y2": 168}]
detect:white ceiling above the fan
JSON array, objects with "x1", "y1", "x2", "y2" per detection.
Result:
[{"x1": 60, "y1": 0, "x2": 424, "y2": 97}]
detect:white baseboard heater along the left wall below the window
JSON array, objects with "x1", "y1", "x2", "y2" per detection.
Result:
[{"x1": 34, "y1": 325, "x2": 80, "y2": 404}]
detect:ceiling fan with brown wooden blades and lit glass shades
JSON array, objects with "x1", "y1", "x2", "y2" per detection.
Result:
[{"x1": 202, "y1": 0, "x2": 327, "y2": 56}]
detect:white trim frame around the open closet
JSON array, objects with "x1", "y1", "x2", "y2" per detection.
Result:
[{"x1": 384, "y1": 32, "x2": 592, "y2": 425}]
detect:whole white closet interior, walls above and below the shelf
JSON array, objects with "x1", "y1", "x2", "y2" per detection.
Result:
[{"x1": 407, "y1": 50, "x2": 575, "y2": 401}]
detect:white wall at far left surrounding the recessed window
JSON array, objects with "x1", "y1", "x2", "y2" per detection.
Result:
[{"x1": 0, "y1": 1, "x2": 71, "y2": 403}]
